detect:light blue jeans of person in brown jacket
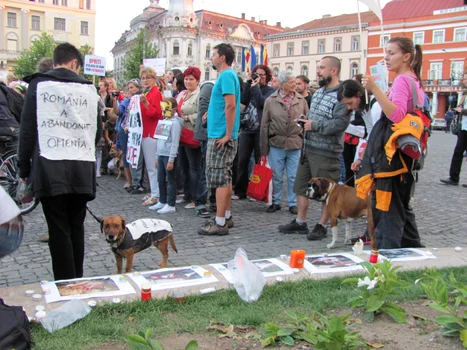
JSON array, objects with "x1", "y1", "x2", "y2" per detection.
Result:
[{"x1": 268, "y1": 147, "x2": 300, "y2": 207}]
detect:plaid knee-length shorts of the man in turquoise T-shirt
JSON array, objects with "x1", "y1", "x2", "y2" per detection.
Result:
[{"x1": 206, "y1": 139, "x2": 238, "y2": 188}]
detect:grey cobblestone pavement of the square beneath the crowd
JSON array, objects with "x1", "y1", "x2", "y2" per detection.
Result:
[{"x1": 0, "y1": 131, "x2": 467, "y2": 287}]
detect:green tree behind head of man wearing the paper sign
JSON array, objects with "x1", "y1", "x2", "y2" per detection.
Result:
[{"x1": 15, "y1": 33, "x2": 57, "y2": 79}]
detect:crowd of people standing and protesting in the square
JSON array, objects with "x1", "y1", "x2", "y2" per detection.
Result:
[{"x1": 0, "y1": 37, "x2": 442, "y2": 279}]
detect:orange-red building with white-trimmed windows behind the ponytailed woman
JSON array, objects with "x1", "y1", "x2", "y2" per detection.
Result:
[{"x1": 368, "y1": 0, "x2": 467, "y2": 118}]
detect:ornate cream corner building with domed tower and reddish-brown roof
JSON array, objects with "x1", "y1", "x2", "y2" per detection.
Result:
[{"x1": 112, "y1": 0, "x2": 284, "y2": 81}]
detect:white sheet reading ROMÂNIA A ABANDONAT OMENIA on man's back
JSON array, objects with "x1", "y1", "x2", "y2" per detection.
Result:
[{"x1": 37, "y1": 81, "x2": 99, "y2": 162}]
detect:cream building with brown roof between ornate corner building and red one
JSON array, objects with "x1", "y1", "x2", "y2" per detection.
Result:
[{"x1": 266, "y1": 12, "x2": 376, "y2": 85}]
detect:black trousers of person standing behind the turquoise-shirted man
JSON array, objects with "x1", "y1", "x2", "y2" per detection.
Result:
[{"x1": 235, "y1": 133, "x2": 260, "y2": 197}]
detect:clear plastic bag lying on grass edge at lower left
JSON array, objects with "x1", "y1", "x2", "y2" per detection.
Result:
[{"x1": 41, "y1": 300, "x2": 91, "y2": 333}]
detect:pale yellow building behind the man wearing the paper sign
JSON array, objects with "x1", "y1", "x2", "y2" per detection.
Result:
[{"x1": 0, "y1": 0, "x2": 97, "y2": 77}]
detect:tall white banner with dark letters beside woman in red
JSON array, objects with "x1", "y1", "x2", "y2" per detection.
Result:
[{"x1": 126, "y1": 95, "x2": 143, "y2": 169}]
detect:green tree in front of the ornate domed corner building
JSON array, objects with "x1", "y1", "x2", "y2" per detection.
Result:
[{"x1": 123, "y1": 29, "x2": 159, "y2": 81}]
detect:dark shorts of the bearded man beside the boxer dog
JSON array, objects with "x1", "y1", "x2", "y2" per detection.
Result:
[{"x1": 293, "y1": 152, "x2": 340, "y2": 196}]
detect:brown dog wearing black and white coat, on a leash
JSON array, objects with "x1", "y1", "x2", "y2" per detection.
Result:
[{"x1": 100, "y1": 215, "x2": 178, "y2": 274}]
